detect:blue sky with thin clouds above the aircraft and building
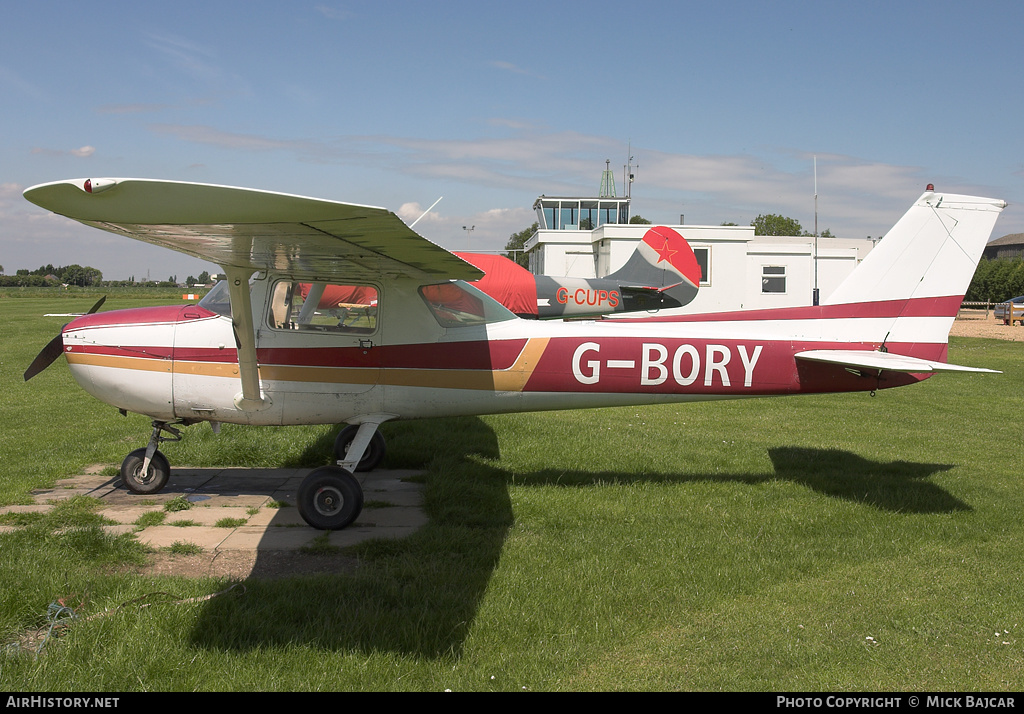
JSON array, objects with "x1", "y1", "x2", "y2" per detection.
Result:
[{"x1": 0, "y1": 0, "x2": 1024, "y2": 280}]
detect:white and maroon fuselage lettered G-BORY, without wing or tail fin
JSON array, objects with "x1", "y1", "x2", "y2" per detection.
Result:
[{"x1": 63, "y1": 279, "x2": 937, "y2": 424}]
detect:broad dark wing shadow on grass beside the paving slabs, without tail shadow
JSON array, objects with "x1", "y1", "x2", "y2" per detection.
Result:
[{"x1": 191, "y1": 418, "x2": 512, "y2": 657}]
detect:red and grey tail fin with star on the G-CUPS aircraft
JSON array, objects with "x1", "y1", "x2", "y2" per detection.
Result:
[{"x1": 606, "y1": 225, "x2": 700, "y2": 305}]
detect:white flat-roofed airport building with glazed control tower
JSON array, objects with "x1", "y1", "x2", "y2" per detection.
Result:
[{"x1": 524, "y1": 196, "x2": 874, "y2": 312}]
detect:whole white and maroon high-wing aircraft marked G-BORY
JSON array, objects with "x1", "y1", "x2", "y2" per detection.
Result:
[{"x1": 25, "y1": 179, "x2": 1006, "y2": 530}]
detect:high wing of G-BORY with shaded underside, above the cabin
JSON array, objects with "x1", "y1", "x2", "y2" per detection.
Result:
[{"x1": 25, "y1": 178, "x2": 483, "y2": 281}]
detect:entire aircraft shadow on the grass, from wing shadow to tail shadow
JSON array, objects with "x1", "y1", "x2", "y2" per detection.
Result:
[{"x1": 191, "y1": 417, "x2": 970, "y2": 657}]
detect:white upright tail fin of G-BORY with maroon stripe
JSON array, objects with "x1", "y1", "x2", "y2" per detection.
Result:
[{"x1": 822, "y1": 186, "x2": 1007, "y2": 359}]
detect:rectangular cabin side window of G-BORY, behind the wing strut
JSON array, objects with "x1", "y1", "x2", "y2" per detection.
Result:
[{"x1": 267, "y1": 281, "x2": 377, "y2": 334}]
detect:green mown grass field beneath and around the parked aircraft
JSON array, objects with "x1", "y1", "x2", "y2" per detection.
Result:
[{"x1": 0, "y1": 298, "x2": 1024, "y2": 691}]
